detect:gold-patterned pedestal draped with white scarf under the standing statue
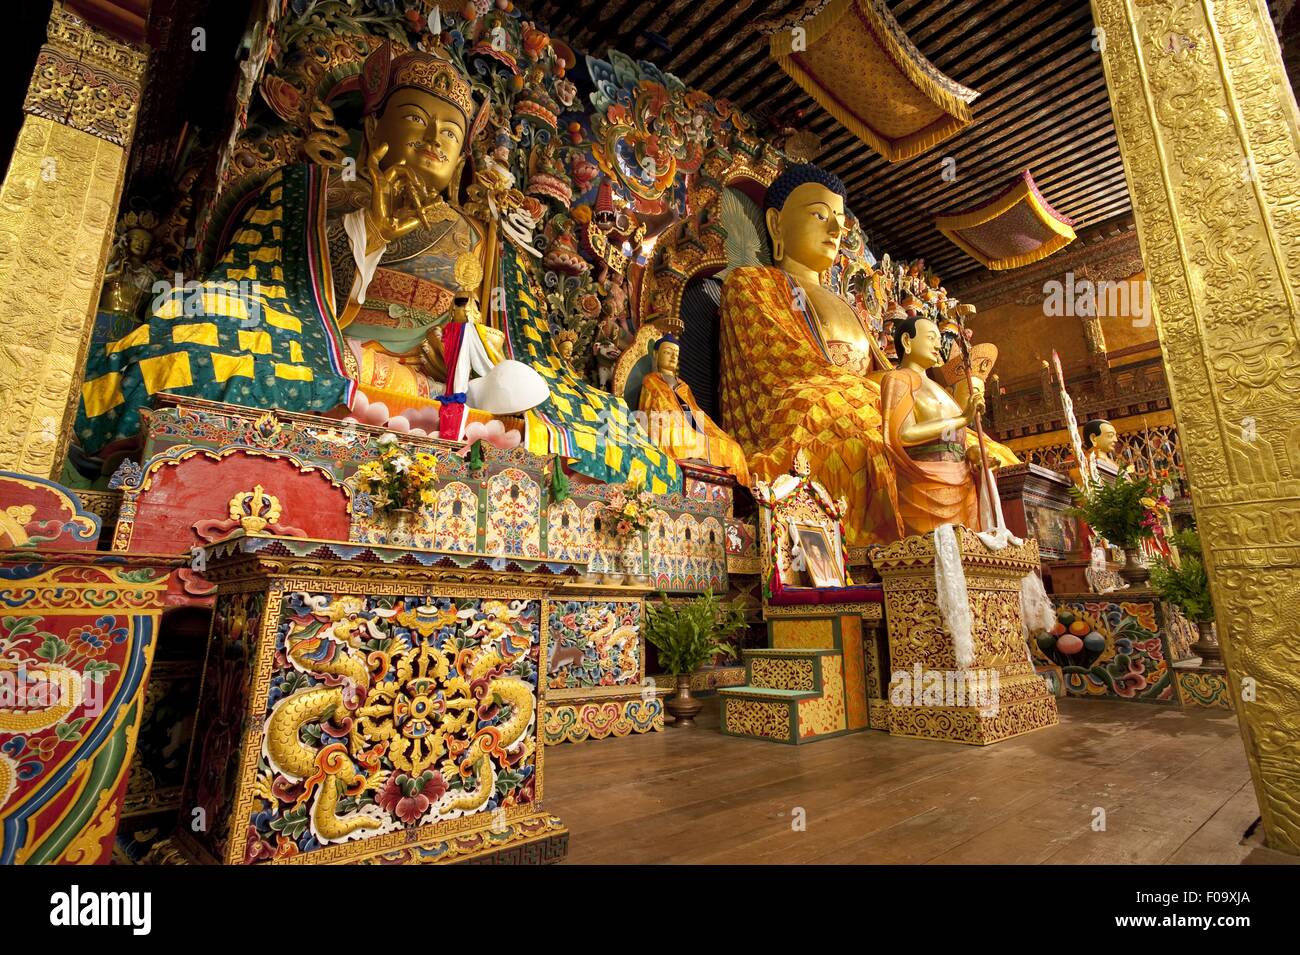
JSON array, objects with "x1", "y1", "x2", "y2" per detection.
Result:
[{"x1": 874, "y1": 528, "x2": 1057, "y2": 745}]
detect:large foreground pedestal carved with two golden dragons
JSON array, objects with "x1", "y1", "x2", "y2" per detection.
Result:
[{"x1": 177, "y1": 534, "x2": 576, "y2": 864}]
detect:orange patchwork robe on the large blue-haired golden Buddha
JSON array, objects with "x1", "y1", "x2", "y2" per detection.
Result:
[{"x1": 722, "y1": 266, "x2": 897, "y2": 547}]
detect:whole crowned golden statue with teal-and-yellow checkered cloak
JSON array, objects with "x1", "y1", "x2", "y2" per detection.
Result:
[{"x1": 75, "y1": 43, "x2": 681, "y2": 492}]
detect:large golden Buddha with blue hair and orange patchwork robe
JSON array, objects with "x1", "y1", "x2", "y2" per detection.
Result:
[{"x1": 722, "y1": 164, "x2": 1015, "y2": 546}]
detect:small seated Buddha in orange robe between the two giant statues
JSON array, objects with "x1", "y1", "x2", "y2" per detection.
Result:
[{"x1": 641, "y1": 335, "x2": 749, "y2": 486}]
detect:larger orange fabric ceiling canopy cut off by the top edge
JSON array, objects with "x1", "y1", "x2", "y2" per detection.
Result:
[{"x1": 759, "y1": 0, "x2": 979, "y2": 162}]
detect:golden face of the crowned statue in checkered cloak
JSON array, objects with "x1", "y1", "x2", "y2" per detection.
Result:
[{"x1": 367, "y1": 87, "x2": 465, "y2": 192}]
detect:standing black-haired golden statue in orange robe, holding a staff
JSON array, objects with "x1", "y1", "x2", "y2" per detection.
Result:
[{"x1": 880, "y1": 317, "x2": 1014, "y2": 537}]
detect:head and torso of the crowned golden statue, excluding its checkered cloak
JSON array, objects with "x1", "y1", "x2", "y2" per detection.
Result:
[{"x1": 326, "y1": 44, "x2": 506, "y2": 424}]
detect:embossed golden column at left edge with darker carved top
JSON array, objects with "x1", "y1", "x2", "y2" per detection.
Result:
[{"x1": 0, "y1": 3, "x2": 147, "y2": 478}]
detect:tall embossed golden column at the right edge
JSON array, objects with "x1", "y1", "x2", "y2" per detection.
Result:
[{"x1": 1092, "y1": 0, "x2": 1300, "y2": 854}]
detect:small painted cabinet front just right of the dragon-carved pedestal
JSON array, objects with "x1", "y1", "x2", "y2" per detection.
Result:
[{"x1": 542, "y1": 583, "x2": 673, "y2": 743}]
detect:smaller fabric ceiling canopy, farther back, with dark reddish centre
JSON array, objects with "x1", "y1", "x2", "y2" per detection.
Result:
[{"x1": 935, "y1": 169, "x2": 1074, "y2": 270}]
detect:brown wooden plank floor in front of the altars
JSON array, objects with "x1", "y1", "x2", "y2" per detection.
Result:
[{"x1": 543, "y1": 700, "x2": 1290, "y2": 864}]
